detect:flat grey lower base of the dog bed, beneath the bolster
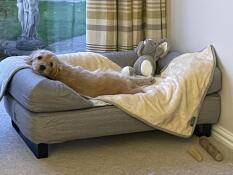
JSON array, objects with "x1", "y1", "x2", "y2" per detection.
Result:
[{"x1": 4, "y1": 94, "x2": 220, "y2": 143}]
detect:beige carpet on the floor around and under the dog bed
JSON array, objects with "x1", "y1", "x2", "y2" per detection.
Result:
[{"x1": 0, "y1": 101, "x2": 233, "y2": 175}]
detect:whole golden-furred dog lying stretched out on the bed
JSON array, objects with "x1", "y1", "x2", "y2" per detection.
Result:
[{"x1": 28, "y1": 50, "x2": 154, "y2": 97}]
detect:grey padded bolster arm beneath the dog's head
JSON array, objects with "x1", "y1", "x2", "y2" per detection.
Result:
[{"x1": 8, "y1": 69, "x2": 93, "y2": 112}]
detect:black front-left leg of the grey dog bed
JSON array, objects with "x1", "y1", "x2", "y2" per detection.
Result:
[{"x1": 11, "y1": 120, "x2": 48, "y2": 159}]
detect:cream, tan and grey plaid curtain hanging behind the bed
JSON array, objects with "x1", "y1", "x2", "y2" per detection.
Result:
[{"x1": 86, "y1": 0, "x2": 167, "y2": 52}]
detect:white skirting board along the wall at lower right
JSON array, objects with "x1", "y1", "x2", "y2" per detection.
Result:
[{"x1": 212, "y1": 125, "x2": 233, "y2": 150}]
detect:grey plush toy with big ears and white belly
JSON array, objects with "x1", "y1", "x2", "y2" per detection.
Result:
[{"x1": 121, "y1": 39, "x2": 169, "y2": 76}]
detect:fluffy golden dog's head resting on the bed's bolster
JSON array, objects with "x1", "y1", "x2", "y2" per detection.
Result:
[{"x1": 28, "y1": 50, "x2": 59, "y2": 78}]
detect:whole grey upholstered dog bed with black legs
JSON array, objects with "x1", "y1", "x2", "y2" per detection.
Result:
[{"x1": 4, "y1": 51, "x2": 221, "y2": 158}]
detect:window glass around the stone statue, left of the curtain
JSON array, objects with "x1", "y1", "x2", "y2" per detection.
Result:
[{"x1": 0, "y1": 0, "x2": 86, "y2": 57}]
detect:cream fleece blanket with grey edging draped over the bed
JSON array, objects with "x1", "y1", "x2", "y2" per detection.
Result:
[{"x1": 59, "y1": 46, "x2": 216, "y2": 137}]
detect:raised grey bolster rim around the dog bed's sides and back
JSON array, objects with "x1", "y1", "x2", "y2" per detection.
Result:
[{"x1": 8, "y1": 51, "x2": 221, "y2": 112}]
